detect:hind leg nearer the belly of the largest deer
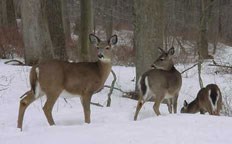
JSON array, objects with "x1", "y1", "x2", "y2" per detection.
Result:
[{"x1": 43, "y1": 95, "x2": 58, "y2": 125}]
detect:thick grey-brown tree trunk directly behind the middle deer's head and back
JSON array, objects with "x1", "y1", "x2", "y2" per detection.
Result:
[{"x1": 134, "y1": 0, "x2": 164, "y2": 89}]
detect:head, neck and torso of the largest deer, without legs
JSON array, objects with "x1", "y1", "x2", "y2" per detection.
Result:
[{"x1": 32, "y1": 34, "x2": 117, "y2": 95}]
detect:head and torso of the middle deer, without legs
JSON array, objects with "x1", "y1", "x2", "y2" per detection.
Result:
[{"x1": 139, "y1": 48, "x2": 182, "y2": 99}]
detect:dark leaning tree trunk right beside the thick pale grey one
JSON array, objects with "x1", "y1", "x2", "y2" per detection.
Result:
[{"x1": 44, "y1": 0, "x2": 67, "y2": 60}]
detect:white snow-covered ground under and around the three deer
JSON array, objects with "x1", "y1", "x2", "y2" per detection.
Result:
[{"x1": 0, "y1": 48, "x2": 232, "y2": 144}]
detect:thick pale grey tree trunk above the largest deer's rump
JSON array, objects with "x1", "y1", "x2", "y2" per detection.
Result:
[{"x1": 21, "y1": 0, "x2": 53, "y2": 65}]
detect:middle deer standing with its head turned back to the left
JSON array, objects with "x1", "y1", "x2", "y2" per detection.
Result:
[{"x1": 134, "y1": 47, "x2": 182, "y2": 120}]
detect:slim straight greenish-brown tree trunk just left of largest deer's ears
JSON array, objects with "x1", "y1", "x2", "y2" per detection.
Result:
[{"x1": 79, "y1": 0, "x2": 93, "y2": 61}]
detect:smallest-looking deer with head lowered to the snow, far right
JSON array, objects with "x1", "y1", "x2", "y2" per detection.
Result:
[{"x1": 181, "y1": 84, "x2": 222, "y2": 115}]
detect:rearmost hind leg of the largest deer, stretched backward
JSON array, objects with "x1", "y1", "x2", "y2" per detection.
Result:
[{"x1": 17, "y1": 90, "x2": 35, "y2": 130}]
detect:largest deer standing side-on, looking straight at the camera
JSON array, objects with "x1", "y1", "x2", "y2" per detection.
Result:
[{"x1": 18, "y1": 34, "x2": 118, "y2": 129}]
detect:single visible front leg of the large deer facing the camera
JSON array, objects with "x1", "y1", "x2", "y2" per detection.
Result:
[{"x1": 81, "y1": 95, "x2": 92, "y2": 123}]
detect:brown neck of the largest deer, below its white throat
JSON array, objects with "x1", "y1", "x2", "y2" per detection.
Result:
[{"x1": 97, "y1": 60, "x2": 112, "y2": 82}]
